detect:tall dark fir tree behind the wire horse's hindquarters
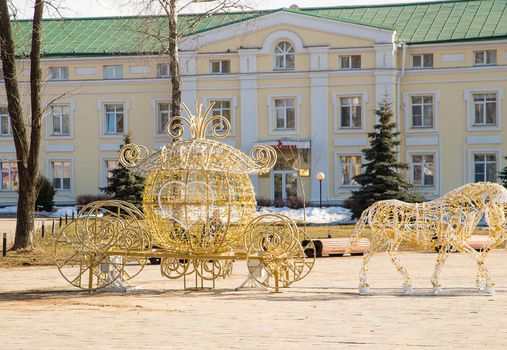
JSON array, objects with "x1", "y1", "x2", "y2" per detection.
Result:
[{"x1": 347, "y1": 98, "x2": 420, "y2": 218}]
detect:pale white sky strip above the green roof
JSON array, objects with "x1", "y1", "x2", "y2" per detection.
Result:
[{"x1": 13, "y1": 0, "x2": 436, "y2": 18}]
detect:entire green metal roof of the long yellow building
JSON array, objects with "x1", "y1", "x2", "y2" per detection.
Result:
[{"x1": 9, "y1": 0, "x2": 507, "y2": 56}]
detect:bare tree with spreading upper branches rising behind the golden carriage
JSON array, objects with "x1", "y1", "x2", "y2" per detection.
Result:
[{"x1": 127, "y1": 0, "x2": 252, "y2": 124}]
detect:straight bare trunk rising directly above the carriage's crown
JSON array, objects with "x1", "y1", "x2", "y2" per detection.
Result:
[{"x1": 168, "y1": 0, "x2": 181, "y2": 140}]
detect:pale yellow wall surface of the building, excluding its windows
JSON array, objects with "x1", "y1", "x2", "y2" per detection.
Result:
[{"x1": 0, "y1": 18, "x2": 507, "y2": 204}]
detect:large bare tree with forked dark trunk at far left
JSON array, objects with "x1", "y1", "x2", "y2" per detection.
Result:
[{"x1": 0, "y1": 0, "x2": 46, "y2": 250}]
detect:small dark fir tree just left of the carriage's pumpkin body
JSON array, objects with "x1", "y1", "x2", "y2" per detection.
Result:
[{"x1": 100, "y1": 135, "x2": 145, "y2": 207}]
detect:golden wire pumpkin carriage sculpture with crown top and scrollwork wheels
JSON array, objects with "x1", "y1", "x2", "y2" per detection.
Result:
[{"x1": 56, "y1": 105, "x2": 316, "y2": 291}]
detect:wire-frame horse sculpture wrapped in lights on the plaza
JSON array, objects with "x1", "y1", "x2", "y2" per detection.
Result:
[{"x1": 351, "y1": 182, "x2": 507, "y2": 294}]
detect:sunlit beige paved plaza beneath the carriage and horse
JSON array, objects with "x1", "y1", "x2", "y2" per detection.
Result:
[{"x1": 0, "y1": 250, "x2": 507, "y2": 349}]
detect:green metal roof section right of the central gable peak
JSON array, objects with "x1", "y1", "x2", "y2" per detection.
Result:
[{"x1": 298, "y1": 0, "x2": 507, "y2": 43}]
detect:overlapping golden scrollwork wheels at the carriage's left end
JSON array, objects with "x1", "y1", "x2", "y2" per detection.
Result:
[{"x1": 55, "y1": 200, "x2": 151, "y2": 290}]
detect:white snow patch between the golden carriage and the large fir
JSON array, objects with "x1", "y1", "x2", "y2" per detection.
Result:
[{"x1": 257, "y1": 207, "x2": 352, "y2": 224}]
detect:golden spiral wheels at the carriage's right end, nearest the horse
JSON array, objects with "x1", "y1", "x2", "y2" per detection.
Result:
[{"x1": 244, "y1": 214, "x2": 315, "y2": 288}]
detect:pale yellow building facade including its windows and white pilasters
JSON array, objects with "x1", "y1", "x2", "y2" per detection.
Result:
[{"x1": 0, "y1": 1, "x2": 507, "y2": 205}]
